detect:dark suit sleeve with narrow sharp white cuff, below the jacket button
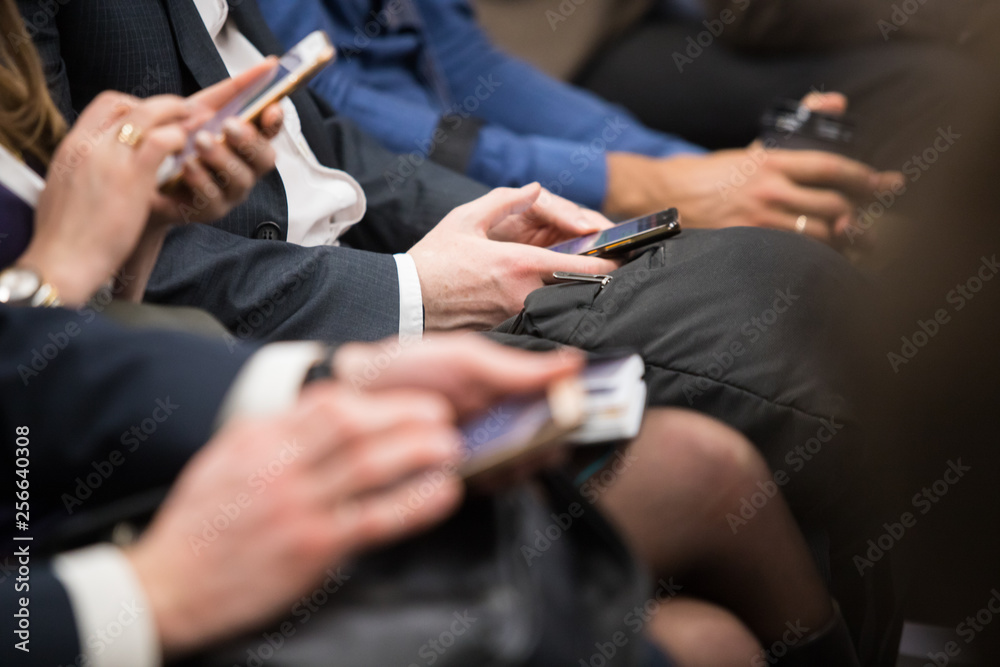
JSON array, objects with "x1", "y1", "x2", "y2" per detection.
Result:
[{"x1": 146, "y1": 225, "x2": 399, "y2": 343}]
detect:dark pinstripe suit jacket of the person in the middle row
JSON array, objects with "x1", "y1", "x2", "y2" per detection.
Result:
[{"x1": 18, "y1": 0, "x2": 486, "y2": 341}]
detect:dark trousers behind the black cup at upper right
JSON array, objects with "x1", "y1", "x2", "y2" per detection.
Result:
[{"x1": 578, "y1": 20, "x2": 986, "y2": 169}]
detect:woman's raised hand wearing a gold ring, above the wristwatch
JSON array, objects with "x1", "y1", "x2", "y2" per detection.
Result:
[{"x1": 18, "y1": 93, "x2": 191, "y2": 306}]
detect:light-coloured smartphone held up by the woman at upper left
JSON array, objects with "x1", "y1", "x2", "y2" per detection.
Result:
[{"x1": 157, "y1": 30, "x2": 337, "y2": 188}]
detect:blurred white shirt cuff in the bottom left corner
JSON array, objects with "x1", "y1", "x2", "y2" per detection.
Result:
[{"x1": 52, "y1": 544, "x2": 161, "y2": 667}]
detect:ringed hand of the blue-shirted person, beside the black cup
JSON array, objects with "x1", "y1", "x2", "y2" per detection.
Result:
[{"x1": 606, "y1": 94, "x2": 904, "y2": 243}]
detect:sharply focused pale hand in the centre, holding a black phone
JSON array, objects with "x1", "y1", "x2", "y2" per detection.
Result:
[{"x1": 409, "y1": 183, "x2": 617, "y2": 331}]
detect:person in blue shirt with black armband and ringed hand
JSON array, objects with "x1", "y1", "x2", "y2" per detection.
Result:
[{"x1": 259, "y1": 0, "x2": 897, "y2": 242}]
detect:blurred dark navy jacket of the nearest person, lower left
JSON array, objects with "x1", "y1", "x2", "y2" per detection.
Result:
[{"x1": 0, "y1": 307, "x2": 254, "y2": 667}]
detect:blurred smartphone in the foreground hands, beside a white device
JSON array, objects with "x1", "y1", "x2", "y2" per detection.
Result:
[{"x1": 459, "y1": 378, "x2": 586, "y2": 482}]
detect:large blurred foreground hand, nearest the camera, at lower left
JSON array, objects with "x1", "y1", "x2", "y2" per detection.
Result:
[{"x1": 127, "y1": 383, "x2": 462, "y2": 658}]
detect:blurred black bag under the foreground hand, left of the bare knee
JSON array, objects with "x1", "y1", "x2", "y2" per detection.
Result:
[{"x1": 175, "y1": 476, "x2": 649, "y2": 667}]
